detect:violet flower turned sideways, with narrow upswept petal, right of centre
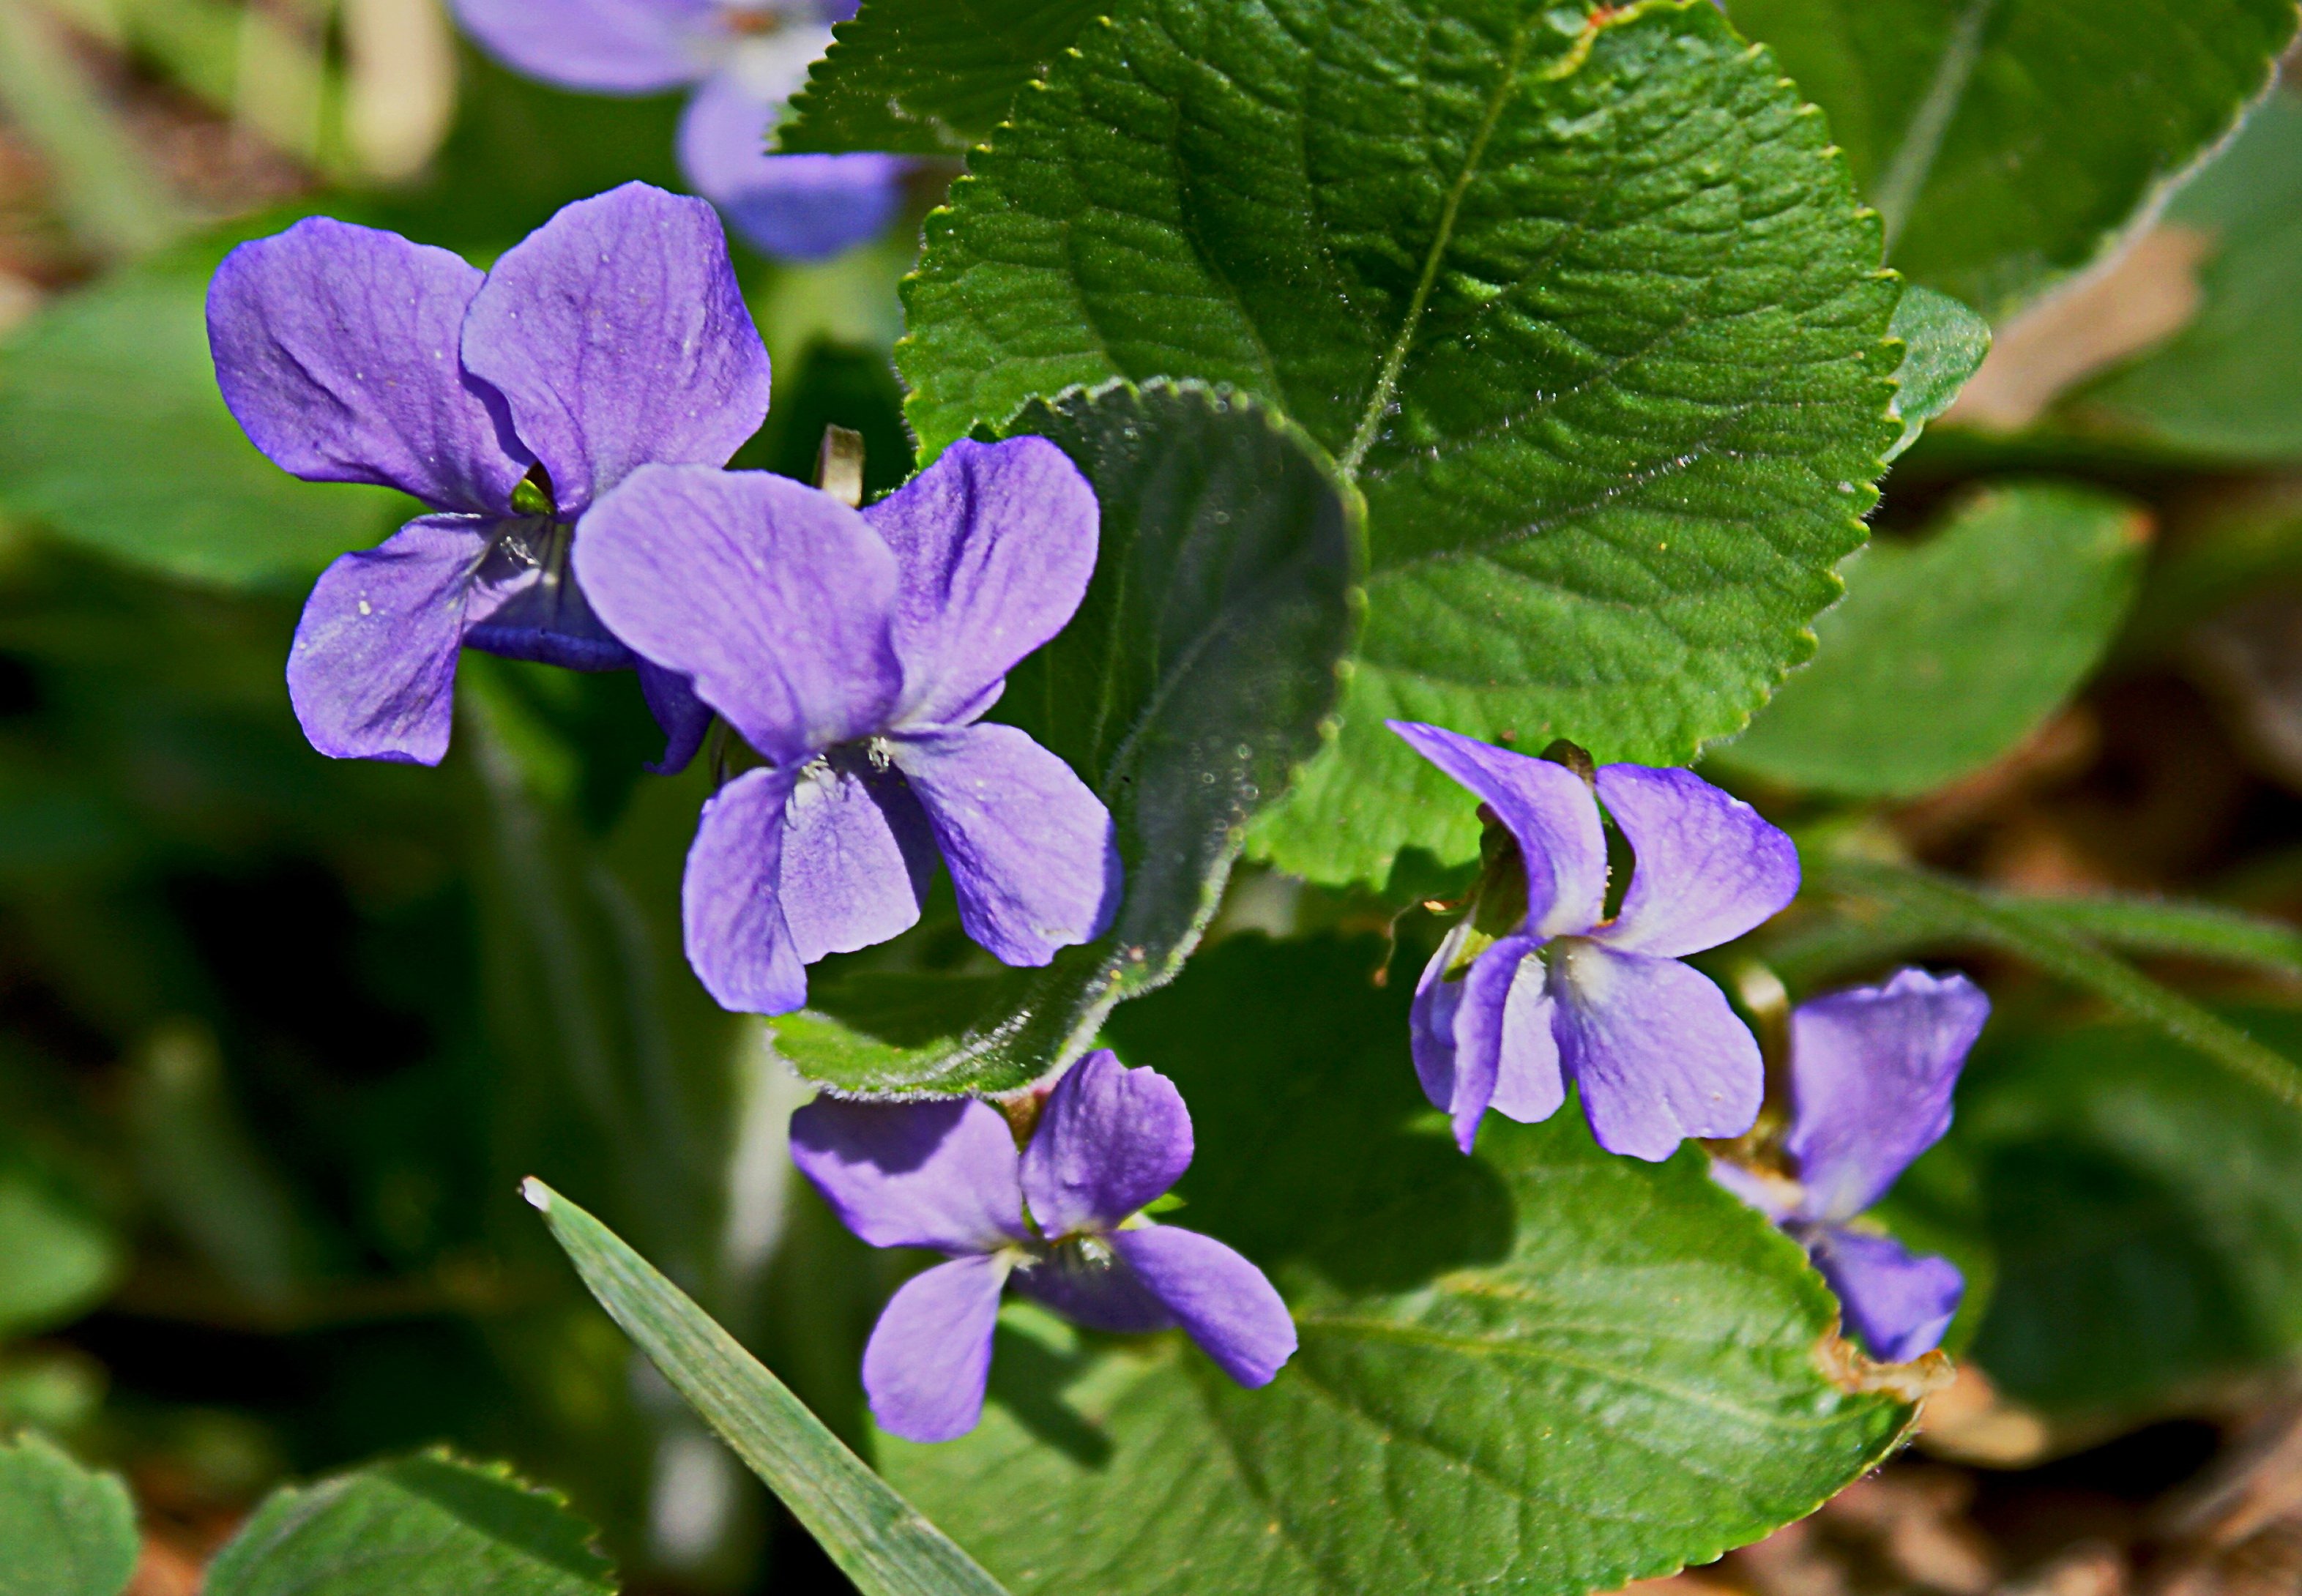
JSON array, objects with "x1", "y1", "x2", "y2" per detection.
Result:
[{"x1": 1390, "y1": 721, "x2": 1798, "y2": 1158}]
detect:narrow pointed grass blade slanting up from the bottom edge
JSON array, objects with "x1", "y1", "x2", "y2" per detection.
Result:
[{"x1": 529, "y1": 1182, "x2": 1004, "y2": 1596}]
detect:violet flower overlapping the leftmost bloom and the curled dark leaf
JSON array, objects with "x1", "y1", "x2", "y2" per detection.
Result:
[{"x1": 576, "y1": 438, "x2": 1119, "y2": 1013}]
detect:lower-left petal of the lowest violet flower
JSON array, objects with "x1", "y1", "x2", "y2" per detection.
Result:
[{"x1": 863, "y1": 1258, "x2": 1010, "y2": 1442}]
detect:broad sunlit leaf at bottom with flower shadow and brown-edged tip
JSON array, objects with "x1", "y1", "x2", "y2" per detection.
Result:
[{"x1": 882, "y1": 935, "x2": 1911, "y2": 1596}]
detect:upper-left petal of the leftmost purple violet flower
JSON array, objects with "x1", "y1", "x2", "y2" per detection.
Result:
[{"x1": 207, "y1": 217, "x2": 527, "y2": 516}]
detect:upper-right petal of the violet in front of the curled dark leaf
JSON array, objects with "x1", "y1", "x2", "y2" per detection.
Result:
[{"x1": 863, "y1": 438, "x2": 1100, "y2": 726}]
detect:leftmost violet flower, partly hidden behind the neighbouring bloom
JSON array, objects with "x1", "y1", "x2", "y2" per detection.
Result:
[{"x1": 207, "y1": 184, "x2": 769, "y2": 769}]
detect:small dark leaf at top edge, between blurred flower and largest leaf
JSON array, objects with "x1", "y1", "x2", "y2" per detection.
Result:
[{"x1": 776, "y1": 0, "x2": 1100, "y2": 154}]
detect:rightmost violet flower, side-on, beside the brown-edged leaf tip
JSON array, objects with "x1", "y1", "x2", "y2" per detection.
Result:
[{"x1": 1710, "y1": 969, "x2": 1992, "y2": 1363}]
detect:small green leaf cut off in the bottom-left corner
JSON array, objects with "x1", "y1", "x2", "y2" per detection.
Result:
[{"x1": 0, "y1": 1435, "x2": 138, "y2": 1596}]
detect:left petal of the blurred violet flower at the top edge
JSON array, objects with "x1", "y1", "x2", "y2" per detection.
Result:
[{"x1": 453, "y1": 0, "x2": 723, "y2": 94}]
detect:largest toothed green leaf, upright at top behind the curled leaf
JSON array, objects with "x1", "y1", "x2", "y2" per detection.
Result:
[{"x1": 898, "y1": 0, "x2": 1897, "y2": 880}]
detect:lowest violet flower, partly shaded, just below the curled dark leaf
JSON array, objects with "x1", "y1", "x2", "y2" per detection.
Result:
[{"x1": 792, "y1": 1050, "x2": 1296, "y2": 1442}]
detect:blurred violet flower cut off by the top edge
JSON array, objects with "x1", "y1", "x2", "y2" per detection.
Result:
[{"x1": 456, "y1": 0, "x2": 912, "y2": 260}]
